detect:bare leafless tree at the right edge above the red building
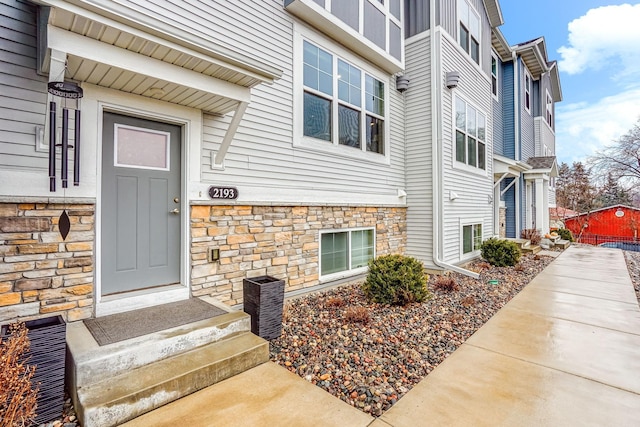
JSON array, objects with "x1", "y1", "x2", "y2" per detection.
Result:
[{"x1": 588, "y1": 119, "x2": 640, "y2": 187}]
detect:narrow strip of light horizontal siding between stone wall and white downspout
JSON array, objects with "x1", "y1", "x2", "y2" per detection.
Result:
[{"x1": 405, "y1": 35, "x2": 433, "y2": 265}]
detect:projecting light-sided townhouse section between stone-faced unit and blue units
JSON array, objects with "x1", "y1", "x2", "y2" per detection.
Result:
[{"x1": 405, "y1": 0, "x2": 503, "y2": 273}]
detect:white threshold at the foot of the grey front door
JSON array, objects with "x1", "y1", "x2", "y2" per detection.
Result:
[{"x1": 96, "y1": 284, "x2": 189, "y2": 317}]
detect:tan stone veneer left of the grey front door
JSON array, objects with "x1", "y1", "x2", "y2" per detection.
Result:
[{"x1": 0, "y1": 203, "x2": 95, "y2": 323}]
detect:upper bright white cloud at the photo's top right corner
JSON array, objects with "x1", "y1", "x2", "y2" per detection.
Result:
[{"x1": 558, "y1": 4, "x2": 640, "y2": 77}]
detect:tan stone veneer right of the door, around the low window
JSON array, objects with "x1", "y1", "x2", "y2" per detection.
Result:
[{"x1": 191, "y1": 205, "x2": 406, "y2": 305}]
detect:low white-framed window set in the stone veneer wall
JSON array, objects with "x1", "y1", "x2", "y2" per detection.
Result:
[{"x1": 320, "y1": 229, "x2": 375, "y2": 276}]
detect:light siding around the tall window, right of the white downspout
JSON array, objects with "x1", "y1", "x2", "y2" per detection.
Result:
[{"x1": 439, "y1": 33, "x2": 493, "y2": 263}]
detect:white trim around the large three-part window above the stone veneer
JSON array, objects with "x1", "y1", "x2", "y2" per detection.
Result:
[{"x1": 292, "y1": 22, "x2": 391, "y2": 165}]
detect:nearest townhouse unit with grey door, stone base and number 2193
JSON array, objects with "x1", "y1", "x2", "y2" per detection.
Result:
[{"x1": 0, "y1": 0, "x2": 406, "y2": 321}]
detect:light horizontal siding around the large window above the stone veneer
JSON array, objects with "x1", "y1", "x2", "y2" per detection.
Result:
[{"x1": 201, "y1": 1, "x2": 405, "y2": 203}]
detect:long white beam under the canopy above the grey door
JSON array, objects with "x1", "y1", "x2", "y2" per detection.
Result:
[{"x1": 47, "y1": 25, "x2": 251, "y2": 102}]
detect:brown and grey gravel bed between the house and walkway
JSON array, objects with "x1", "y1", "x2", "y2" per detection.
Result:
[{"x1": 270, "y1": 255, "x2": 553, "y2": 416}]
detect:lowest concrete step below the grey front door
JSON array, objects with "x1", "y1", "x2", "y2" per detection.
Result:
[{"x1": 75, "y1": 332, "x2": 269, "y2": 427}]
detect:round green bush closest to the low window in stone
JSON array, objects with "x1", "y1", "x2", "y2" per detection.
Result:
[{"x1": 362, "y1": 255, "x2": 429, "y2": 305}]
